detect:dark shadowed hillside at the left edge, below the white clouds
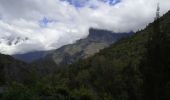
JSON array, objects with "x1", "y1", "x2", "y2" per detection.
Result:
[{"x1": 0, "y1": 54, "x2": 31, "y2": 85}]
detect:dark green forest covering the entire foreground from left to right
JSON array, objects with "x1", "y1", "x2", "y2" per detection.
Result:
[{"x1": 0, "y1": 12, "x2": 170, "y2": 100}]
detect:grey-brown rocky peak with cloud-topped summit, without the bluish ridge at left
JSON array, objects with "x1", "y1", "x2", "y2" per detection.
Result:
[{"x1": 41, "y1": 28, "x2": 133, "y2": 65}]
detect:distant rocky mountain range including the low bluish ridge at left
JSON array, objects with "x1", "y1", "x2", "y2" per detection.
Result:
[{"x1": 13, "y1": 28, "x2": 133, "y2": 65}]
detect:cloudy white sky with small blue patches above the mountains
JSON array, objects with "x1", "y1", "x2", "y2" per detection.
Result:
[{"x1": 0, "y1": 0, "x2": 170, "y2": 54}]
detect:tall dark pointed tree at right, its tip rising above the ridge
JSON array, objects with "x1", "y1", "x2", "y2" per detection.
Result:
[{"x1": 141, "y1": 5, "x2": 170, "y2": 100}]
